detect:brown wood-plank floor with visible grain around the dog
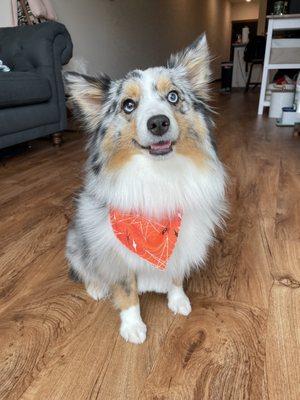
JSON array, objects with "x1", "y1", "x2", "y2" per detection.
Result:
[{"x1": 0, "y1": 93, "x2": 300, "y2": 400}]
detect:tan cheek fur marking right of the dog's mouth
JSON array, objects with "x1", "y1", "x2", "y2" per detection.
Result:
[{"x1": 175, "y1": 113, "x2": 207, "y2": 168}]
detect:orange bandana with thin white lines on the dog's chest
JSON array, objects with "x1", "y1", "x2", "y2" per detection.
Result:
[{"x1": 109, "y1": 209, "x2": 182, "y2": 269}]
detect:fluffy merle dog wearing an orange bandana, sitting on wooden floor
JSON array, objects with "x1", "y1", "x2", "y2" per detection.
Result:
[{"x1": 64, "y1": 34, "x2": 226, "y2": 344}]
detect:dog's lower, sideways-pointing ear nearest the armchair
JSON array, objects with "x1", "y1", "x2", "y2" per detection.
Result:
[{"x1": 64, "y1": 72, "x2": 111, "y2": 131}]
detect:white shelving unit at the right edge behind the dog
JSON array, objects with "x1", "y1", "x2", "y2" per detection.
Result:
[{"x1": 258, "y1": 14, "x2": 300, "y2": 115}]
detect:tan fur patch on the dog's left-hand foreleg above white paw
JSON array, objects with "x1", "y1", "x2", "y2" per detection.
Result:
[{"x1": 112, "y1": 273, "x2": 139, "y2": 311}]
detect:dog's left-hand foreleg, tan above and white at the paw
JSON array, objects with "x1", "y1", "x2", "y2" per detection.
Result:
[{"x1": 113, "y1": 273, "x2": 147, "y2": 344}]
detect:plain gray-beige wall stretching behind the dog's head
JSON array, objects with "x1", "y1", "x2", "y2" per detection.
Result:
[{"x1": 52, "y1": 0, "x2": 231, "y2": 78}]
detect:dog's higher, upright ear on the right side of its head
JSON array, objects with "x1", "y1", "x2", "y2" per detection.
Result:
[{"x1": 168, "y1": 33, "x2": 211, "y2": 99}]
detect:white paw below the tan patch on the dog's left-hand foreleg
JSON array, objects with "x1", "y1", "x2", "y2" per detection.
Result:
[{"x1": 120, "y1": 306, "x2": 147, "y2": 344}]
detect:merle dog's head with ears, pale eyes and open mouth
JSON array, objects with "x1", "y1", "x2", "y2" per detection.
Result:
[{"x1": 65, "y1": 36, "x2": 214, "y2": 173}]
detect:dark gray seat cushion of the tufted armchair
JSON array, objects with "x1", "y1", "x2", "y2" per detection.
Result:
[{"x1": 0, "y1": 72, "x2": 51, "y2": 108}]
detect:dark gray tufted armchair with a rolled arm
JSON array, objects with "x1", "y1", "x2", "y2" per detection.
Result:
[{"x1": 0, "y1": 22, "x2": 73, "y2": 148}]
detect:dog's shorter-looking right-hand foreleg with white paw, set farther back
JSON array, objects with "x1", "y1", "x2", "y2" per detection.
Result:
[{"x1": 168, "y1": 278, "x2": 192, "y2": 315}]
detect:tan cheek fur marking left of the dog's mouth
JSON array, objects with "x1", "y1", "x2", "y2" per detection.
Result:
[{"x1": 102, "y1": 120, "x2": 141, "y2": 171}]
